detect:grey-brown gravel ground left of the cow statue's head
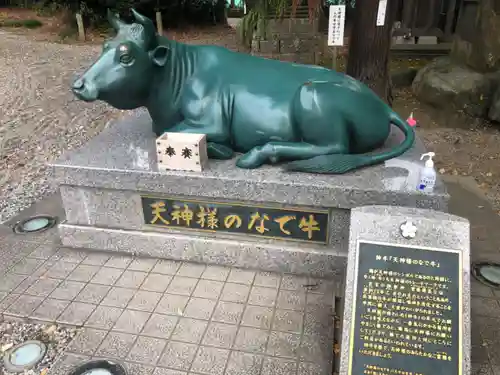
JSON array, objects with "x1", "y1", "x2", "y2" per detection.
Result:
[{"x1": 0, "y1": 31, "x2": 119, "y2": 222}]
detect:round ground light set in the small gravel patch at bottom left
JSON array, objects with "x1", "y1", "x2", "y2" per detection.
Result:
[{"x1": 3, "y1": 341, "x2": 47, "y2": 372}]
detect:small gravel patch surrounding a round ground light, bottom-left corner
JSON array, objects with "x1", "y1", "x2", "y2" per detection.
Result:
[{"x1": 0, "y1": 321, "x2": 78, "y2": 375}]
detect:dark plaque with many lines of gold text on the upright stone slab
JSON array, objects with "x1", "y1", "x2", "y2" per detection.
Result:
[{"x1": 348, "y1": 242, "x2": 463, "y2": 375}]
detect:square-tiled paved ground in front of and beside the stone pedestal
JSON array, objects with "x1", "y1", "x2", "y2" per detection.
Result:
[{"x1": 0, "y1": 183, "x2": 500, "y2": 375}]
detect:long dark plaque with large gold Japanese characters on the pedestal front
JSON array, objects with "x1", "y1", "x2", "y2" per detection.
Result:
[{"x1": 141, "y1": 197, "x2": 329, "y2": 243}]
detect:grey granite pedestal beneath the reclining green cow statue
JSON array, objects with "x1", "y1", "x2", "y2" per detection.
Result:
[{"x1": 52, "y1": 111, "x2": 449, "y2": 276}]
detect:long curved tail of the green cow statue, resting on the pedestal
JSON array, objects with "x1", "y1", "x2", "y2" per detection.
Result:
[{"x1": 285, "y1": 112, "x2": 415, "y2": 174}]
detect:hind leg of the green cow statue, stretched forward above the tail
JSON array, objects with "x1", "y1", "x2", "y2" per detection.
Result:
[{"x1": 236, "y1": 142, "x2": 347, "y2": 169}]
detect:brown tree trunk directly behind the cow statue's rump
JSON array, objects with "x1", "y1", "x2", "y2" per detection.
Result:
[{"x1": 347, "y1": 0, "x2": 397, "y2": 105}]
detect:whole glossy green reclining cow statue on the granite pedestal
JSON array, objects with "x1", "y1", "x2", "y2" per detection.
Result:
[{"x1": 73, "y1": 11, "x2": 414, "y2": 173}]
